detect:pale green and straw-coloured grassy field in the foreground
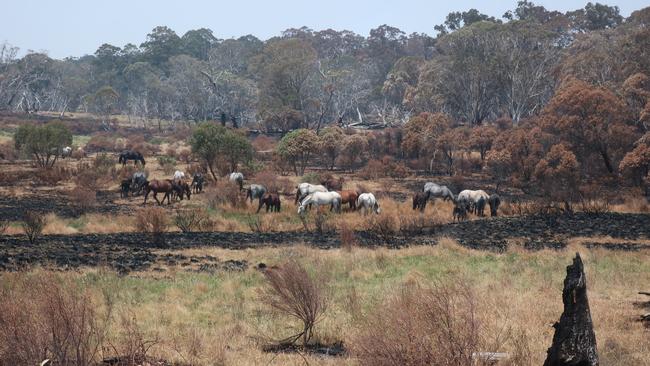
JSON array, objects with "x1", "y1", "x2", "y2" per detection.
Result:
[{"x1": 5, "y1": 240, "x2": 650, "y2": 365}]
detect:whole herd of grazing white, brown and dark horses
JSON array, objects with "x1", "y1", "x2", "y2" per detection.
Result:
[{"x1": 112, "y1": 150, "x2": 501, "y2": 221}]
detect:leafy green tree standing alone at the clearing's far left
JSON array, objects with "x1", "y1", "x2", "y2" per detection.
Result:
[{"x1": 14, "y1": 122, "x2": 72, "y2": 169}]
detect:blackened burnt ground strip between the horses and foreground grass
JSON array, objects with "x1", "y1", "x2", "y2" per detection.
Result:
[{"x1": 0, "y1": 213, "x2": 650, "y2": 273}]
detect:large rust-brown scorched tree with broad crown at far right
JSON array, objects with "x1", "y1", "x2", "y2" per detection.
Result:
[{"x1": 541, "y1": 79, "x2": 635, "y2": 174}]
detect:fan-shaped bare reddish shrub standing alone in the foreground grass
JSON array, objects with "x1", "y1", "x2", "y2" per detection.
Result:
[{"x1": 262, "y1": 260, "x2": 328, "y2": 346}]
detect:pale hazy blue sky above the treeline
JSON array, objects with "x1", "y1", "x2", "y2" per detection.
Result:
[{"x1": 0, "y1": 0, "x2": 650, "y2": 58}]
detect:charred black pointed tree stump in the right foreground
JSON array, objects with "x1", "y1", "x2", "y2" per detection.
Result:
[{"x1": 544, "y1": 253, "x2": 598, "y2": 366}]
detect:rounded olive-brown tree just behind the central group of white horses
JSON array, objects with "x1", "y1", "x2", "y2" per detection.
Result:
[{"x1": 277, "y1": 129, "x2": 319, "y2": 175}]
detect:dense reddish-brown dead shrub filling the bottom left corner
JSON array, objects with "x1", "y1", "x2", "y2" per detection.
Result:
[{"x1": 0, "y1": 273, "x2": 112, "y2": 366}]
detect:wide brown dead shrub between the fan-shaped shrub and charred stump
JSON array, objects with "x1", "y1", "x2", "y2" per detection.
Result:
[{"x1": 351, "y1": 280, "x2": 500, "y2": 366}]
